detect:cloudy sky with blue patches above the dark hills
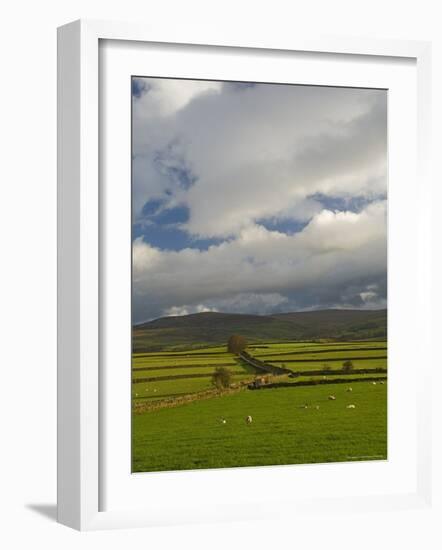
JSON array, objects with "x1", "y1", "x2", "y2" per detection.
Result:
[{"x1": 132, "y1": 77, "x2": 387, "y2": 323}]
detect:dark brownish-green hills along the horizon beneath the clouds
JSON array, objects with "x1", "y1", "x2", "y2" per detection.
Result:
[{"x1": 133, "y1": 309, "x2": 387, "y2": 352}]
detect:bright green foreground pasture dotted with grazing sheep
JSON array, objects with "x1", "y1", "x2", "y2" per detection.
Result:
[{"x1": 132, "y1": 382, "x2": 387, "y2": 472}]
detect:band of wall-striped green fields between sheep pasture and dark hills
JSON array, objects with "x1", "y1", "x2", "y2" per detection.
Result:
[{"x1": 132, "y1": 341, "x2": 387, "y2": 400}]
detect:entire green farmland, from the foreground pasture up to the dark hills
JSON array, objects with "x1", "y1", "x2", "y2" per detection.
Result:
[{"x1": 132, "y1": 340, "x2": 387, "y2": 472}]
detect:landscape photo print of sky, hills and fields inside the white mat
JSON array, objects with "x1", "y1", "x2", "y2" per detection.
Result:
[{"x1": 130, "y1": 76, "x2": 388, "y2": 472}]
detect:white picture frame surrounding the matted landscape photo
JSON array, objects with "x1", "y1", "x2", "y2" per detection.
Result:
[{"x1": 58, "y1": 21, "x2": 432, "y2": 530}]
